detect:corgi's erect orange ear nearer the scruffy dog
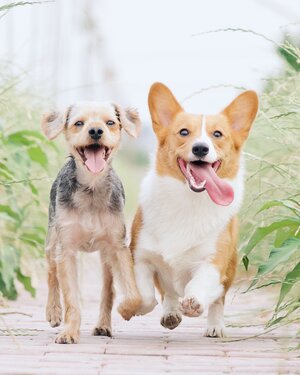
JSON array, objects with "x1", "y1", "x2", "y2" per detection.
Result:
[{"x1": 148, "y1": 82, "x2": 183, "y2": 132}]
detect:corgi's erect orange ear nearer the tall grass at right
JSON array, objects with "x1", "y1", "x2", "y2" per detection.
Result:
[{"x1": 222, "y1": 91, "x2": 258, "y2": 145}]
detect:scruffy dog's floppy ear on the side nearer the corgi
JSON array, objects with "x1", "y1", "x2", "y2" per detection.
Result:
[{"x1": 113, "y1": 103, "x2": 141, "y2": 138}]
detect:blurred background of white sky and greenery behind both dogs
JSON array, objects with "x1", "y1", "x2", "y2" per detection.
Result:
[{"x1": 0, "y1": 0, "x2": 300, "y2": 328}]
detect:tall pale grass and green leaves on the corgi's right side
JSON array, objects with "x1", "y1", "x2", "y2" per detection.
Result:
[{"x1": 241, "y1": 37, "x2": 300, "y2": 332}]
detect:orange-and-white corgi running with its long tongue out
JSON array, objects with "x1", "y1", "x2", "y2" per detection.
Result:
[{"x1": 130, "y1": 83, "x2": 258, "y2": 337}]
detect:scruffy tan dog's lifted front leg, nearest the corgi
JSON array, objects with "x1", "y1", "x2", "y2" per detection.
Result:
[{"x1": 113, "y1": 246, "x2": 141, "y2": 320}]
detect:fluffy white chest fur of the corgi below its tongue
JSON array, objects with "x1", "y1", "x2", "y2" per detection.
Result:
[{"x1": 137, "y1": 172, "x2": 243, "y2": 265}]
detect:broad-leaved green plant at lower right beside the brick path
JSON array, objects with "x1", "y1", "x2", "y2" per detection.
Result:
[{"x1": 242, "y1": 199, "x2": 300, "y2": 326}]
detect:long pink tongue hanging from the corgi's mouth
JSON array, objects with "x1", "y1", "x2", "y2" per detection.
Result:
[{"x1": 189, "y1": 163, "x2": 234, "y2": 206}]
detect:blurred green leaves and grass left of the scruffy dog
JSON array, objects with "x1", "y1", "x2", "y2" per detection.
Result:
[{"x1": 0, "y1": 67, "x2": 56, "y2": 299}]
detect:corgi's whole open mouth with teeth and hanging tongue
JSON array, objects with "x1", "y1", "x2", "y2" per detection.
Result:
[{"x1": 178, "y1": 158, "x2": 234, "y2": 206}]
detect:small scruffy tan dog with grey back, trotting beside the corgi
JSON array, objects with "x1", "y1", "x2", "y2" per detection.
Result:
[{"x1": 42, "y1": 102, "x2": 141, "y2": 344}]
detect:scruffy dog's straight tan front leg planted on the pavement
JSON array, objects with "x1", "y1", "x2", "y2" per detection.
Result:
[{"x1": 55, "y1": 255, "x2": 81, "y2": 344}]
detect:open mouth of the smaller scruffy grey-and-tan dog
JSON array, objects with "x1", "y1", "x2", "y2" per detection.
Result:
[{"x1": 76, "y1": 143, "x2": 112, "y2": 174}]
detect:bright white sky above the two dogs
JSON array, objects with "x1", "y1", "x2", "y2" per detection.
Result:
[{"x1": 0, "y1": 0, "x2": 300, "y2": 122}]
